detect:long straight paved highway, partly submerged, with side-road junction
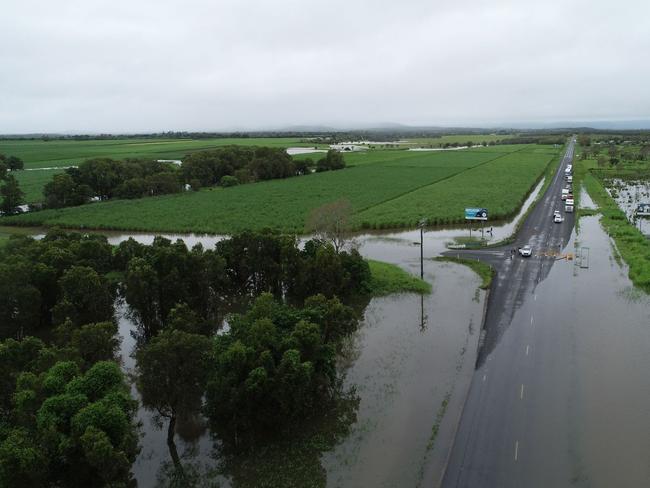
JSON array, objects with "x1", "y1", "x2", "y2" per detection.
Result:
[{"x1": 442, "y1": 141, "x2": 580, "y2": 488}]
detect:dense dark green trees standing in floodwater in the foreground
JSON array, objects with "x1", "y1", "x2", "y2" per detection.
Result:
[{"x1": 0, "y1": 230, "x2": 370, "y2": 486}]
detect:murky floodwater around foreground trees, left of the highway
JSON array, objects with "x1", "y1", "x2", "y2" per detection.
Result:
[{"x1": 119, "y1": 234, "x2": 484, "y2": 487}]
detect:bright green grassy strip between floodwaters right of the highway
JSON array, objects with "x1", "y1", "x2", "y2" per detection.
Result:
[{"x1": 579, "y1": 160, "x2": 650, "y2": 293}]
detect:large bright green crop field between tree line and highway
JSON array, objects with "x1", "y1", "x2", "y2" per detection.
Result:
[{"x1": 0, "y1": 146, "x2": 559, "y2": 234}]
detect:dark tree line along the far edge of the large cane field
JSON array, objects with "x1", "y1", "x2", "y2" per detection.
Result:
[{"x1": 38, "y1": 146, "x2": 345, "y2": 208}]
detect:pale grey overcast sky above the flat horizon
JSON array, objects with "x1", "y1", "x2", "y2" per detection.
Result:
[{"x1": 0, "y1": 0, "x2": 650, "y2": 133}]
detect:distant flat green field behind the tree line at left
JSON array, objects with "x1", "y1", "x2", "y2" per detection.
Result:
[{"x1": 0, "y1": 137, "x2": 313, "y2": 168}]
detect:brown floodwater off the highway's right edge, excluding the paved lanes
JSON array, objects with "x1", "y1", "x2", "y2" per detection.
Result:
[{"x1": 569, "y1": 217, "x2": 650, "y2": 487}]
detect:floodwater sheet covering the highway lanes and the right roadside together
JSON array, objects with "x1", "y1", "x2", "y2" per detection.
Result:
[{"x1": 466, "y1": 216, "x2": 650, "y2": 488}]
